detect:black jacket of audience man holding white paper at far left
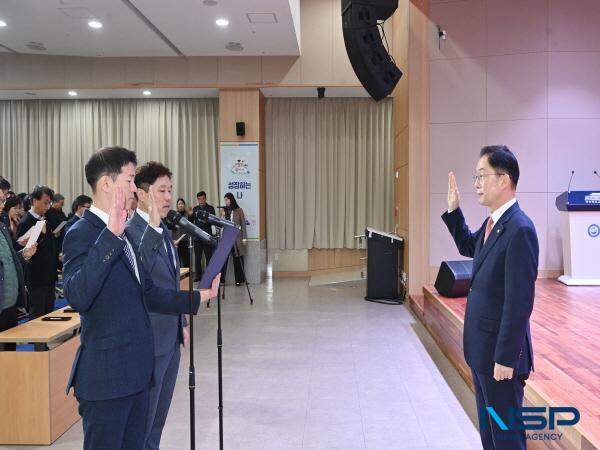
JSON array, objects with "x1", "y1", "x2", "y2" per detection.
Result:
[{"x1": 17, "y1": 213, "x2": 59, "y2": 286}]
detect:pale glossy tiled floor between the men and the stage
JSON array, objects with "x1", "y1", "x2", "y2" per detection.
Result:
[{"x1": 3, "y1": 279, "x2": 480, "y2": 450}]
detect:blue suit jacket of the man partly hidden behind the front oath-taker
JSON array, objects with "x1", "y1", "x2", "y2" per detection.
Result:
[{"x1": 125, "y1": 212, "x2": 183, "y2": 356}]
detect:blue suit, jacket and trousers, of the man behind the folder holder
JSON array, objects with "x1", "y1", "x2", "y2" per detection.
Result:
[{"x1": 126, "y1": 212, "x2": 183, "y2": 450}]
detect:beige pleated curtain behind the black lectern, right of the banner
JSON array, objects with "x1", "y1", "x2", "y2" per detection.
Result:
[{"x1": 266, "y1": 98, "x2": 393, "y2": 249}]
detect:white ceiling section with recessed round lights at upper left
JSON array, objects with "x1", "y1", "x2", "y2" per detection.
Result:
[{"x1": 0, "y1": 0, "x2": 300, "y2": 57}]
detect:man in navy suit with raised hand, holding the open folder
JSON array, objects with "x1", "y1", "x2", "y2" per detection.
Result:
[{"x1": 63, "y1": 147, "x2": 219, "y2": 450}]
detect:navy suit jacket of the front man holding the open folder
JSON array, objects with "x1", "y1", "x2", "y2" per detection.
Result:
[{"x1": 64, "y1": 211, "x2": 200, "y2": 401}]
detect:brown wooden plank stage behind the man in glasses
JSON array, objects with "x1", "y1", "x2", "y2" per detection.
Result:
[{"x1": 410, "y1": 279, "x2": 600, "y2": 450}]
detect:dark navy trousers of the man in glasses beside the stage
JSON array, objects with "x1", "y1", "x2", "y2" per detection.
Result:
[{"x1": 471, "y1": 370, "x2": 528, "y2": 450}]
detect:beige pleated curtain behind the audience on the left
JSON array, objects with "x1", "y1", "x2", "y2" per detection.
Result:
[{"x1": 0, "y1": 99, "x2": 219, "y2": 207}]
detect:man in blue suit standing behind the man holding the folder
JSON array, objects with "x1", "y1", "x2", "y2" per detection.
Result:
[{"x1": 125, "y1": 161, "x2": 187, "y2": 450}]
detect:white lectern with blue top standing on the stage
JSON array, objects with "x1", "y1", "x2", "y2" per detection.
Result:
[{"x1": 556, "y1": 191, "x2": 600, "y2": 286}]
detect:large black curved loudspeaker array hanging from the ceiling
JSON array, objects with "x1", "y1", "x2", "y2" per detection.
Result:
[{"x1": 342, "y1": 0, "x2": 402, "y2": 101}]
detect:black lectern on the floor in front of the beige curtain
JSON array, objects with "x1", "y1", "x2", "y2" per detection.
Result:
[{"x1": 365, "y1": 228, "x2": 406, "y2": 305}]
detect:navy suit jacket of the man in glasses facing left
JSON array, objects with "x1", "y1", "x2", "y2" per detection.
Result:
[{"x1": 442, "y1": 203, "x2": 539, "y2": 375}]
